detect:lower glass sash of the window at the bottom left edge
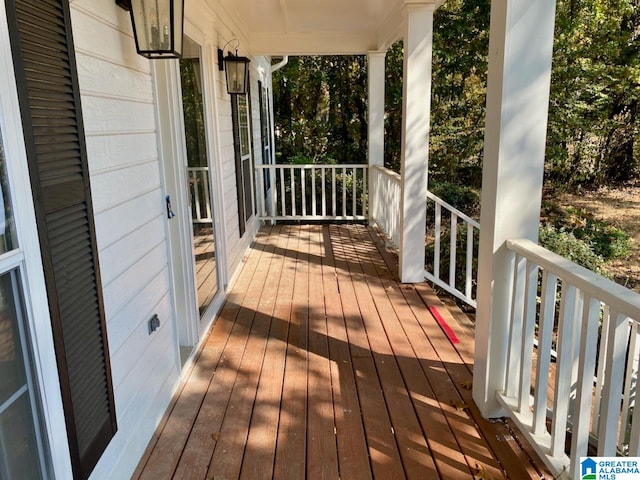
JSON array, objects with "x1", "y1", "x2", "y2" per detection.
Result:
[{"x1": 0, "y1": 271, "x2": 44, "y2": 480}]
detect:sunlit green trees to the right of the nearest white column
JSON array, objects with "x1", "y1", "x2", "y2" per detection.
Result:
[{"x1": 547, "y1": 0, "x2": 640, "y2": 186}]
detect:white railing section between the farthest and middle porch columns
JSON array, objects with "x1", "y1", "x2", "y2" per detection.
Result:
[{"x1": 370, "y1": 166, "x2": 402, "y2": 248}]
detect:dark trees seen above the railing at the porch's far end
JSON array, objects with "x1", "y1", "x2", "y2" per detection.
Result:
[{"x1": 273, "y1": 55, "x2": 367, "y2": 163}]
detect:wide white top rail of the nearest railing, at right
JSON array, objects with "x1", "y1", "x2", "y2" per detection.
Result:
[{"x1": 506, "y1": 239, "x2": 640, "y2": 322}]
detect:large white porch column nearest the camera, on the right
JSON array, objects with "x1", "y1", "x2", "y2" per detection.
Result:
[{"x1": 473, "y1": 0, "x2": 555, "y2": 417}]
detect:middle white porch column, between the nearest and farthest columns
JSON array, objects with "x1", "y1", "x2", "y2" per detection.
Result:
[{"x1": 399, "y1": 3, "x2": 436, "y2": 282}]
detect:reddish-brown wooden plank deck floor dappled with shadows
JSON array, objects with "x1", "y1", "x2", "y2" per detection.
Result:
[{"x1": 134, "y1": 225, "x2": 552, "y2": 480}]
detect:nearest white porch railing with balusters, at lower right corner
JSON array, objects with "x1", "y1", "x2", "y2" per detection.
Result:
[{"x1": 498, "y1": 240, "x2": 640, "y2": 478}]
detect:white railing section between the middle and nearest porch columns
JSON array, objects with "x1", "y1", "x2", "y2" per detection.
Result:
[{"x1": 424, "y1": 192, "x2": 480, "y2": 308}]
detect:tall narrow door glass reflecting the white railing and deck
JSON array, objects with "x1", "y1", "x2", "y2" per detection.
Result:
[{"x1": 180, "y1": 37, "x2": 219, "y2": 317}]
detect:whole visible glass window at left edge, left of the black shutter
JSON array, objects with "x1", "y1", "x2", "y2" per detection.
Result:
[{"x1": 0, "y1": 129, "x2": 47, "y2": 480}]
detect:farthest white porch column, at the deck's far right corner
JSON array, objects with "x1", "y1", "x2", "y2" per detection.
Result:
[{"x1": 367, "y1": 52, "x2": 386, "y2": 222}]
